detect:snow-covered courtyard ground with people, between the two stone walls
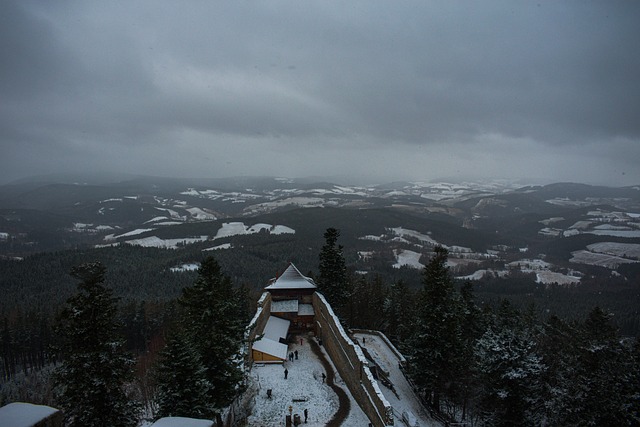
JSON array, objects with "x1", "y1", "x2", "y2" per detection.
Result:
[{"x1": 247, "y1": 337, "x2": 369, "y2": 427}]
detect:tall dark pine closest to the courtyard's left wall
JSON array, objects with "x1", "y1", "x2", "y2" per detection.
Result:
[{"x1": 178, "y1": 256, "x2": 245, "y2": 422}]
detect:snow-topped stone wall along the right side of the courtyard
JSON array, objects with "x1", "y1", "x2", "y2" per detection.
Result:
[{"x1": 313, "y1": 292, "x2": 393, "y2": 427}]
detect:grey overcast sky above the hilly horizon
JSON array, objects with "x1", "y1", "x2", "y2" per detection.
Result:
[{"x1": 0, "y1": 0, "x2": 640, "y2": 185}]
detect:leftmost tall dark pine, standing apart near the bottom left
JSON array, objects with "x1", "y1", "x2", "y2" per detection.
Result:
[{"x1": 54, "y1": 262, "x2": 138, "y2": 427}]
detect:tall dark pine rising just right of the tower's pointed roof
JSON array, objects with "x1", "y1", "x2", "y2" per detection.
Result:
[{"x1": 317, "y1": 228, "x2": 351, "y2": 317}]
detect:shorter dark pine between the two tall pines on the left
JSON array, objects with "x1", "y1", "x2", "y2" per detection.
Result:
[{"x1": 156, "y1": 335, "x2": 209, "y2": 418}]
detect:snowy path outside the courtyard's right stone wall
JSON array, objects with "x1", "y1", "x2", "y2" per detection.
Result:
[{"x1": 354, "y1": 333, "x2": 440, "y2": 427}]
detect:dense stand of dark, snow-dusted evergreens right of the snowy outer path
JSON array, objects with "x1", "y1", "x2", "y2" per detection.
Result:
[{"x1": 401, "y1": 248, "x2": 640, "y2": 426}]
